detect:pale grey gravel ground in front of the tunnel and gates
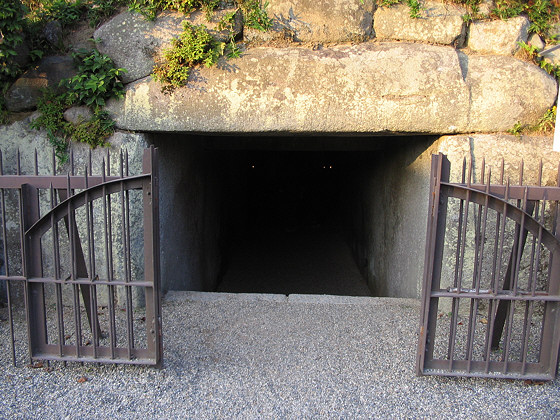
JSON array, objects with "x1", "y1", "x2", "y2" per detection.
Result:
[{"x1": 0, "y1": 292, "x2": 560, "y2": 419}]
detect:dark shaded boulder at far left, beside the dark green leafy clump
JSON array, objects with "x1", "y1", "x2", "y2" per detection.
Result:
[{"x1": 4, "y1": 56, "x2": 76, "y2": 112}]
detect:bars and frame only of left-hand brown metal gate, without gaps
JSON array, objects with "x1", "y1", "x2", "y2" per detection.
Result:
[{"x1": 0, "y1": 146, "x2": 163, "y2": 367}]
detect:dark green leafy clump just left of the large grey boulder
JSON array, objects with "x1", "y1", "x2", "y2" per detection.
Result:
[{"x1": 61, "y1": 50, "x2": 126, "y2": 108}]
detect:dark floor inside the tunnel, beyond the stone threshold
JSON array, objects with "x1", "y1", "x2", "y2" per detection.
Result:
[{"x1": 217, "y1": 226, "x2": 371, "y2": 296}]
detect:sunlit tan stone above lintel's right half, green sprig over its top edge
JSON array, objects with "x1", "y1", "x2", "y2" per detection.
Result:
[{"x1": 373, "y1": 1, "x2": 466, "y2": 47}]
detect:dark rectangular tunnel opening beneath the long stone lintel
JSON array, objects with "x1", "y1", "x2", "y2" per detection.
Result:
[{"x1": 153, "y1": 134, "x2": 434, "y2": 296}]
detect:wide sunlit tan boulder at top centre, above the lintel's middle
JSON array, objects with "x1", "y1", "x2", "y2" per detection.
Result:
[{"x1": 244, "y1": 0, "x2": 374, "y2": 42}]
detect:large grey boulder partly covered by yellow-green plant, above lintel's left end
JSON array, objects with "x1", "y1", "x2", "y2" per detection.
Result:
[{"x1": 94, "y1": 9, "x2": 241, "y2": 83}]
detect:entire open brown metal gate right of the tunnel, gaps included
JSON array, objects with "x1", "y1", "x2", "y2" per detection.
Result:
[{"x1": 417, "y1": 154, "x2": 560, "y2": 380}]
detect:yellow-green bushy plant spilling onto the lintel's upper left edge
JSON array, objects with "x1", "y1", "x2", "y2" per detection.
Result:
[{"x1": 154, "y1": 22, "x2": 225, "y2": 90}]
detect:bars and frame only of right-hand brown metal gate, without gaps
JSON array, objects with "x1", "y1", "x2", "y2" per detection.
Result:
[{"x1": 416, "y1": 153, "x2": 560, "y2": 380}]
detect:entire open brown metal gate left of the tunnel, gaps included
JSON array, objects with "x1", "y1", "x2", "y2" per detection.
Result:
[{"x1": 0, "y1": 147, "x2": 162, "y2": 366}]
